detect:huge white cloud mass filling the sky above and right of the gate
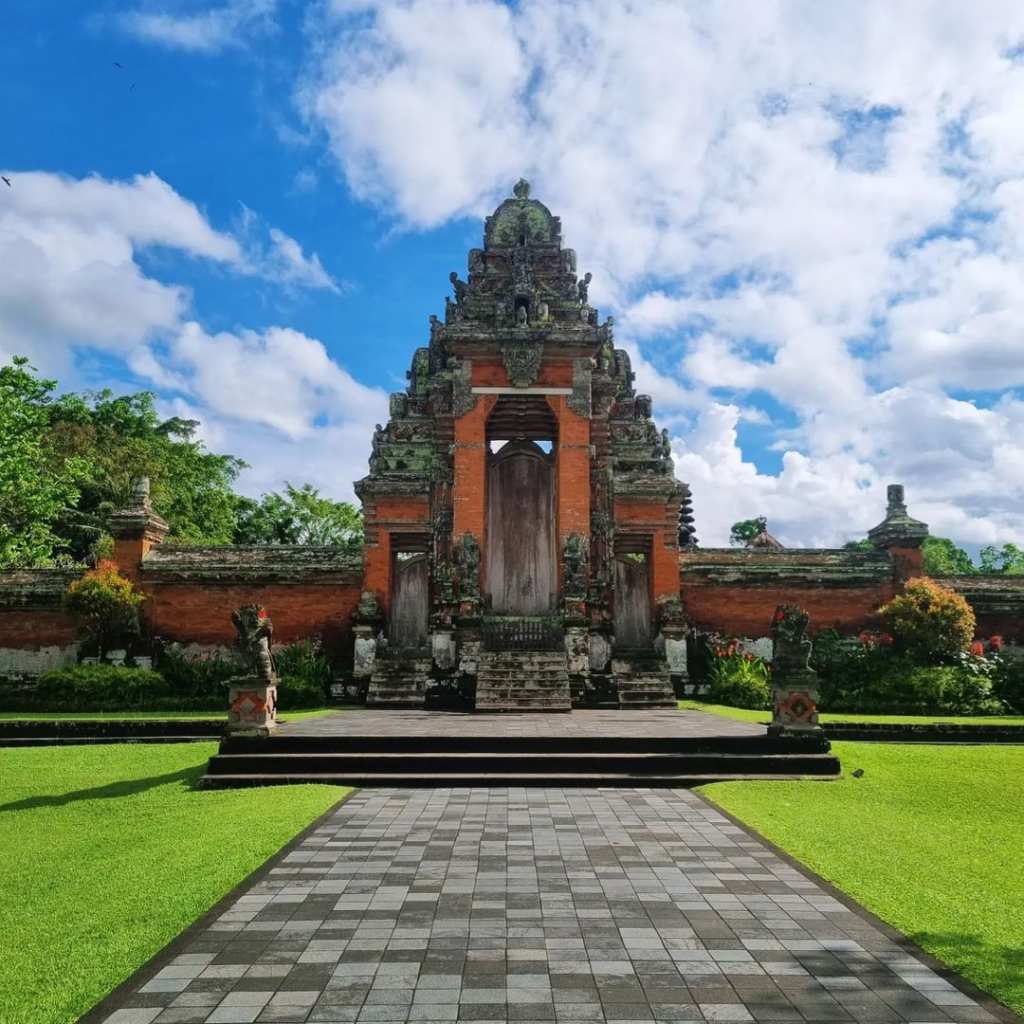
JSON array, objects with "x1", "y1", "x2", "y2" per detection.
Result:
[{"x1": 298, "y1": 0, "x2": 1024, "y2": 544}]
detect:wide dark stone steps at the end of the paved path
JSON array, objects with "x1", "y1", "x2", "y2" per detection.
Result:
[{"x1": 201, "y1": 733, "x2": 839, "y2": 788}]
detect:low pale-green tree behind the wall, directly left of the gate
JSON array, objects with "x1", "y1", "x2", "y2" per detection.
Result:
[{"x1": 234, "y1": 483, "x2": 362, "y2": 548}]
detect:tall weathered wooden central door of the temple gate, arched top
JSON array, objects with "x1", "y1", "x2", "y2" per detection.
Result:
[{"x1": 486, "y1": 440, "x2": 558, "y2": 615}]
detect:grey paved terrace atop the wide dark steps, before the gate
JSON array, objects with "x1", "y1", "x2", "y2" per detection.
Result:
[{"x1": 280, "y1": 709, "x2": 770, "y2": 738}]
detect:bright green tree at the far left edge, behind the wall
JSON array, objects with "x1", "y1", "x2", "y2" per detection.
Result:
[{"x1": 0, "y1": 356, "x2": 88, "y2": 568}]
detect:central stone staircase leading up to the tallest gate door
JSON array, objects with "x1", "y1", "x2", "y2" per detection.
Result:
[{"x1": 476, "y1": 650, "x2": 572, "y2": 712}]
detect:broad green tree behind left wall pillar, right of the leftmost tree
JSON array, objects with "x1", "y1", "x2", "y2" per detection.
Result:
[{"x1": 45, "y1": 391, "x2": 245, "y2": 559}]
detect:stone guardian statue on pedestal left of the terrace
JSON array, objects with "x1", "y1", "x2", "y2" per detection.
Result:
[{"x1": 224, "y1": 604, "x2": 278, "y2": 736}]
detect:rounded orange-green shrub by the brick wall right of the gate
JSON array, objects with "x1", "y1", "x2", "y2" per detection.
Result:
[{"x1": 879, "y1": 578, "x2": 975, "y2": 665}]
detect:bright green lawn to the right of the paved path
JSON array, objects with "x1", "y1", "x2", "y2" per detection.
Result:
[{"x1": 700, "y1": 742, "x2": 1024, "y2": 1012}]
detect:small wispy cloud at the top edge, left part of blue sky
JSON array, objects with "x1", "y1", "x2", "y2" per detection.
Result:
[{"x1": 117, "y1": 0, "x2": 278, "y2": 53}]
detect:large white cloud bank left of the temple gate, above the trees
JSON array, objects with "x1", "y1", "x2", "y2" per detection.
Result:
[{"x1": 0, "y1": 172, "x2": 387, "y2": 497}]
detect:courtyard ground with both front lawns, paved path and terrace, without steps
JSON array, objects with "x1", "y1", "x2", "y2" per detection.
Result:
[{"x1": 0, "y1": 710, "x2": 1024, "y2": 1024}]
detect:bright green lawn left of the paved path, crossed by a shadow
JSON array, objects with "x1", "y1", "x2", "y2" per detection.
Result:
[{"x1": 0, "y1": 742, "x2": 349, "y2": 1024}]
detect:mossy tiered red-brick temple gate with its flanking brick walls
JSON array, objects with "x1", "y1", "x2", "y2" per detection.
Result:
[{"x1": 0, "y1": 181, "x2": 1024, "y2": 712}]
